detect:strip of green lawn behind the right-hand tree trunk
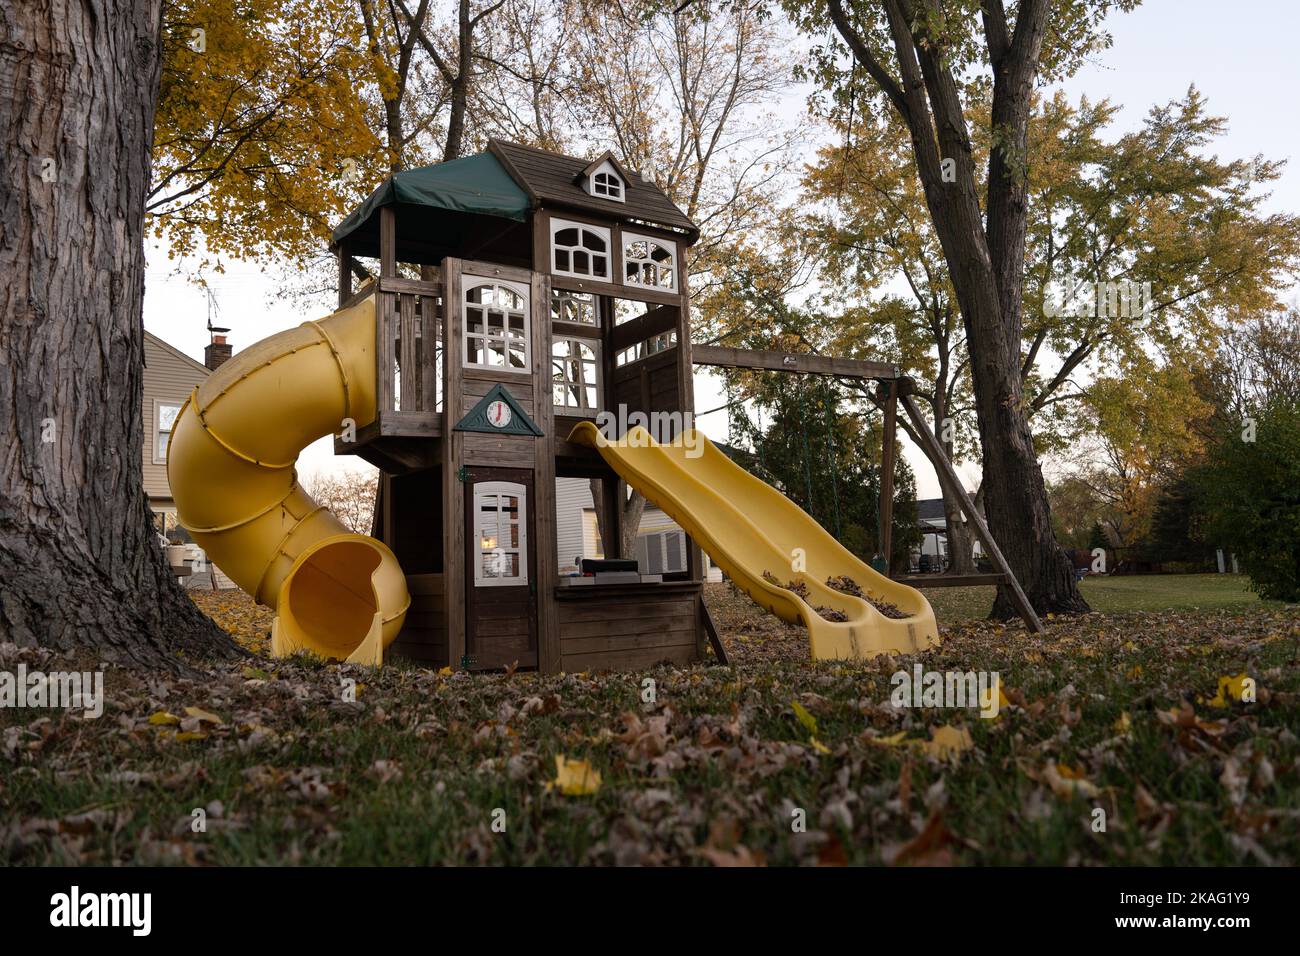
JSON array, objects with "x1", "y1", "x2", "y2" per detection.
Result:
[{"x1": 924, "y1": 574, "x2": 1260, "y2": 623}]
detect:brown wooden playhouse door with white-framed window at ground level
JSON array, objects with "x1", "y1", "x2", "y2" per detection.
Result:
[{"x1": 465, "y1": 467, "x2": 537, "y2": 670}]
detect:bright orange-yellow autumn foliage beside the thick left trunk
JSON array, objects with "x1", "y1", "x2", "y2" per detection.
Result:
[{"x1": 146, "y1": 0, "x2": 389, "y2": 265}]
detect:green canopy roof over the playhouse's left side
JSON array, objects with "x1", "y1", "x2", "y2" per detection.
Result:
[{"x1": 334, "y1": 152, "x2": 530, "y2": 242}]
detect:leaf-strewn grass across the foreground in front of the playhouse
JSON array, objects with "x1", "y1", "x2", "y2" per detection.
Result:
[{"x1": 0, "y1": 579, "x2": 1300, "y2": 865}]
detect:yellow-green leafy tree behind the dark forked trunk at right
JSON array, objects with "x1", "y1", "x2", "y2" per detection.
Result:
[{"x1": 800, "y1": 88, "x2": 1300, "y2": 574}]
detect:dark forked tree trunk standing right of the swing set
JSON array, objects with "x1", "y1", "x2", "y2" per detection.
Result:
[{"x1": 828, "y1": 0, "x2": 1088, "y2": 618}]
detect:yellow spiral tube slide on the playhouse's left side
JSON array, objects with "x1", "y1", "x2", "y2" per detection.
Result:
[{"x1": 168, "y1": 297, "x2": 411, "y2": 665}]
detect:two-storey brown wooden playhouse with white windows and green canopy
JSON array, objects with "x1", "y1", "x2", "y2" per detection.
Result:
[{"x1": 325, "y1": 140, "x2": 716, "y2": 672}]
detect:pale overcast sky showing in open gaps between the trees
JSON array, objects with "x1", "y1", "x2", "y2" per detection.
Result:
[{"x1": 144, "y1": 0, "x2": 1300, "y2": 498}]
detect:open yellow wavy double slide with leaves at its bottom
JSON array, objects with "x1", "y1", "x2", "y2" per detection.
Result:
[{"x1": 569, "y1": 421, "x2": 939, "y2": 661}]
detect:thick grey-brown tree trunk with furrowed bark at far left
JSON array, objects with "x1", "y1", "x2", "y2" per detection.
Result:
[{"x1": 0, "y1": 0, "x2": 238, "y2": 666}]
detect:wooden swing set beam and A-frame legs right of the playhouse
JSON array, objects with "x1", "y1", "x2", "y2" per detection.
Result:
[{"x1": 690, "y1": 345, "x2": 1044, "y2": 633}]
